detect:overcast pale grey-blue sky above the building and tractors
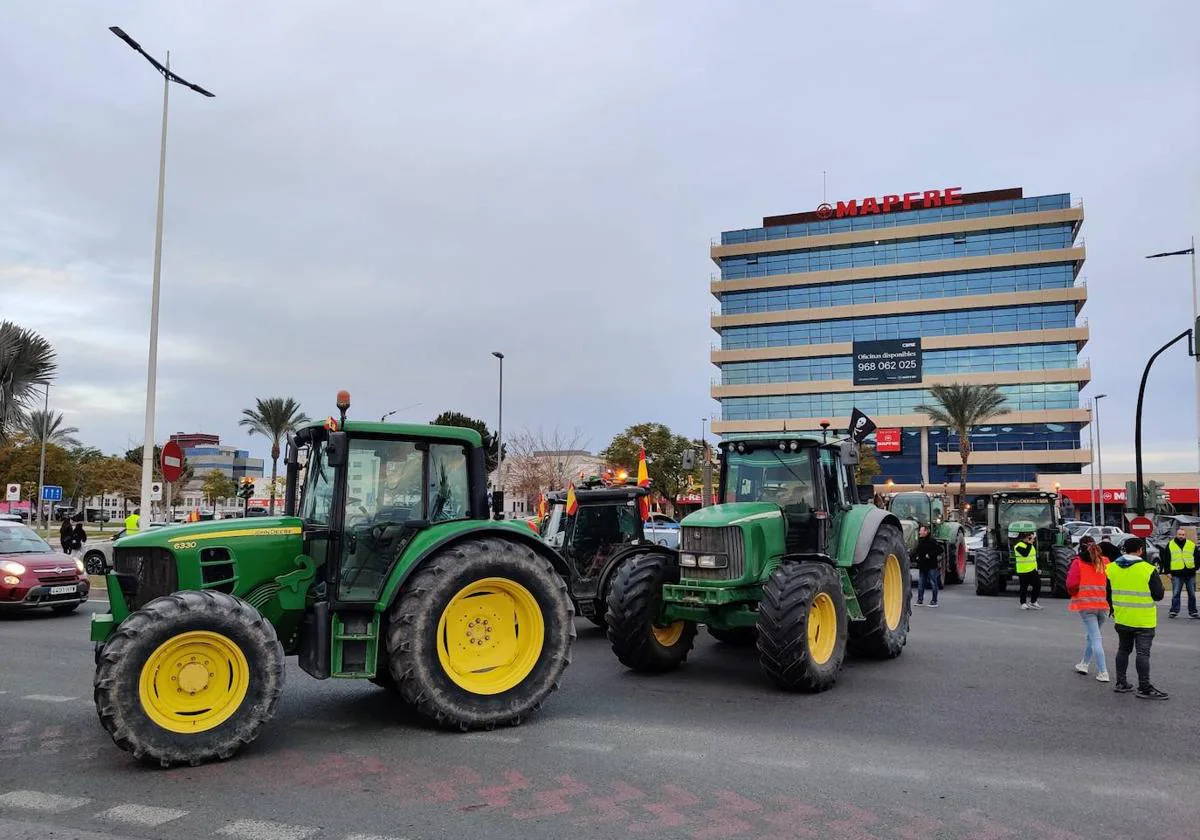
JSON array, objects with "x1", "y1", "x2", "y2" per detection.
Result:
[{"x1": 0, "y1": 0, "x2": 1200, "y2": 470}]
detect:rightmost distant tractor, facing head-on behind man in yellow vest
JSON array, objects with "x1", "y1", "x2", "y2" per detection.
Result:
[{"x1": 976, "y1": 491, "x2": 1075, "y2": 598}]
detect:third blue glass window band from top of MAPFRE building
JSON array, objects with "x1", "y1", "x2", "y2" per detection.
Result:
[{"x1": 721, "y1": 263, "x2": 1075, "y2": 314}]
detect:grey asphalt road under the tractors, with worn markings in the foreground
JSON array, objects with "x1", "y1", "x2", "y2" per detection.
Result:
[{"x1": 0, "y1": 571, "x2": 1200, "y2": 840}]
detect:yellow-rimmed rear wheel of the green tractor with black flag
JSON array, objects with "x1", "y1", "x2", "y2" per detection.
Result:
[{"x1": 848, "y1": 524, "x2": 912, "y2": 659}]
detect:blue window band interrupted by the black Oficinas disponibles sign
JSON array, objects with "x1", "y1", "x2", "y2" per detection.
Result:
[{"x1": 721, "y1": 343, "x2": 1079, "y2": 385}]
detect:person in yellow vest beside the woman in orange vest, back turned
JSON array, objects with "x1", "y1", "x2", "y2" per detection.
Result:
[{"x1": 1104, "y1": 536, "x2": 1168, "y2": 700}]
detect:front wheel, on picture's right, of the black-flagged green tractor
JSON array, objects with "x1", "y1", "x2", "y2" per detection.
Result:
[{"x1": 758, "y1": 563, "x2": 850, "y2": 691}]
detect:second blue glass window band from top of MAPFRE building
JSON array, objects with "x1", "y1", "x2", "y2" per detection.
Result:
[{"x1": 721, "y1": 224, "x2": 1074, "y2": 280}]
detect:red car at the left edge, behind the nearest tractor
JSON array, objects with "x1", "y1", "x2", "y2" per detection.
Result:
[{"x1": 0, "y1": 521, "x2": 89, "y2": 613}]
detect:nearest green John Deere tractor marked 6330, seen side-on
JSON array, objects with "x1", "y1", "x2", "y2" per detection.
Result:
[{"x1": 91, "y1": 391, "x2": 575, "y2": 767}]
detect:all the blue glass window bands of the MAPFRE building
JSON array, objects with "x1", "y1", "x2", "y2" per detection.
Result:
[{"x1": 716, "y1": 193, "x2": 1080, "y2": 484}]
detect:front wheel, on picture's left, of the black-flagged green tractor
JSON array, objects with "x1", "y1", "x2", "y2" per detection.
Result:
[{"x1": 606, "y1": 552, "x2": 696, "y2": 673}]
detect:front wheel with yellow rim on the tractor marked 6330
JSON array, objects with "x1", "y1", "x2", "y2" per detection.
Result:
[{"x1": 95, "y1": 590, "x2": 284, "y2": 767}]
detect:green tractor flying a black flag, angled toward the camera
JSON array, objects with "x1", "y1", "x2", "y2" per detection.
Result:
[{"x1": 606, "y1": 432, "x2": 912, "y2": 691}]
